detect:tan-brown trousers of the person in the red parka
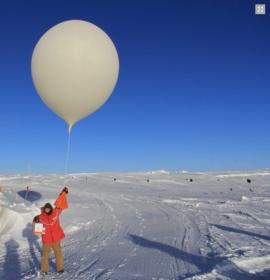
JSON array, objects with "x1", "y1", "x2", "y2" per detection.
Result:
[{"x1": 41, "y1": 242, "x2": 64, "y2": 272}]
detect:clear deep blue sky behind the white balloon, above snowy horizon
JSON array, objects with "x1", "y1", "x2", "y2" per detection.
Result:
[{"x1": 0, "y1": 0, "x2": 270, "y2": 172}]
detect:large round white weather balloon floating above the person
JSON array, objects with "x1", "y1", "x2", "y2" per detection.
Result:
[{"x1": 31, "y1": 20, "x2": 119, "y2": 131}]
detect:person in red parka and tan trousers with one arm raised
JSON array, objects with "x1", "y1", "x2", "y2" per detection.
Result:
[{"x1": 33, "y1": 187, "x2": 68, "y2": 274}]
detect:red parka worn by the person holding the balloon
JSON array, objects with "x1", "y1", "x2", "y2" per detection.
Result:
[{"x1": 39, "y1": 208, "x2": 65, "y2": 244}]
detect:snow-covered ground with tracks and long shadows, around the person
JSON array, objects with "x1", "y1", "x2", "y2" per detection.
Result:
[{"x1": 0, "y1": 170, "x2": 270, "y2": 280}]
